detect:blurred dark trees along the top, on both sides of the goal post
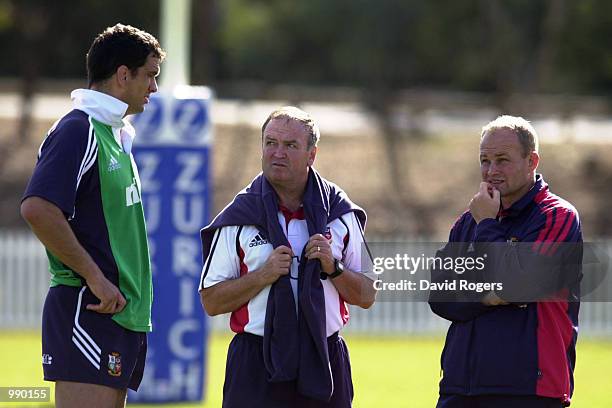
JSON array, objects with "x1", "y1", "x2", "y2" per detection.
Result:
[{"x1": 0, "y1": 0, "x2": 612, "y2": 94}]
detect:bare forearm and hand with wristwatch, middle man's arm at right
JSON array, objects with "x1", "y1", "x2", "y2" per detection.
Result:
[{"x1": 306, "y1": 234, "x2": 376, "y2": 309}]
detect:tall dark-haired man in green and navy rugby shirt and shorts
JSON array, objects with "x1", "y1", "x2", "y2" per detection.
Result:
[{"x1": 21, "y1": 24, "x2": 165, "y2": 408}]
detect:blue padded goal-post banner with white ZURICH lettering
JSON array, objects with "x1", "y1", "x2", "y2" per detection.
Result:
[{"x1": 129, "y1": 87, "x2": 212, "y2": 403}]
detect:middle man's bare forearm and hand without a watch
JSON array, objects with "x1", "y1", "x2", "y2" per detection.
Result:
[{"x1": 200, "y1": 246, "x2": 293, "y2": 316}]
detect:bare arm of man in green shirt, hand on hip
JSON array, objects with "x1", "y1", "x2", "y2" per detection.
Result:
[{"x1": 21, "y1": 197, "x2": 126, "y2": 313}]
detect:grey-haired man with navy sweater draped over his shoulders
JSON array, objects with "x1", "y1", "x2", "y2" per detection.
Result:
[{"x1": 200, "y1": 106, "x2": 375, "y2": 408}]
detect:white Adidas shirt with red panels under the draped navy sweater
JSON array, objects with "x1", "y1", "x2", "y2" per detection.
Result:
[{"x1": 200, "y1": 207, "x2": 364, "y2": 336}]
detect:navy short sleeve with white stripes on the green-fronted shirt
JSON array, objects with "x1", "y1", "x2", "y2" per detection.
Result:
[{"x1": 23, "y1": 111, "x2": 97, "y2": 217}]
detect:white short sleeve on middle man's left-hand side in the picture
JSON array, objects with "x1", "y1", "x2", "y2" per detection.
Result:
[{"x1": 200, "y1": 226, "x2": 240, "y2": 290}]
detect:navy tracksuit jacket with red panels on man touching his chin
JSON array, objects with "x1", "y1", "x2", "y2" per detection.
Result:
[{"x1": 430, "y1": 175, "x2": 582, "y2": 405}]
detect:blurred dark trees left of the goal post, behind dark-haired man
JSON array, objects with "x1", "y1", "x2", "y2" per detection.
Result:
[{"x1": 0, "y1": 0, "x2": 159, "y2": 78}]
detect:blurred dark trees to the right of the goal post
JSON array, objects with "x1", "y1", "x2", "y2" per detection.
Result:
[{"x1": 216, "y1": 0, "x2": 612, "y2": 93}]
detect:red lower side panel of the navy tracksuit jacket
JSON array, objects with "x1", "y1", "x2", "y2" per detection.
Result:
[{"x1": 536, "y1": 301, "x2": 573, "y2": 402}]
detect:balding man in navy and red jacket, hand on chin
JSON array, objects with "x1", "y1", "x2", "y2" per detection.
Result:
[{"x1": 430, "y1": 116, "x2": 582, "y2": 408}]
